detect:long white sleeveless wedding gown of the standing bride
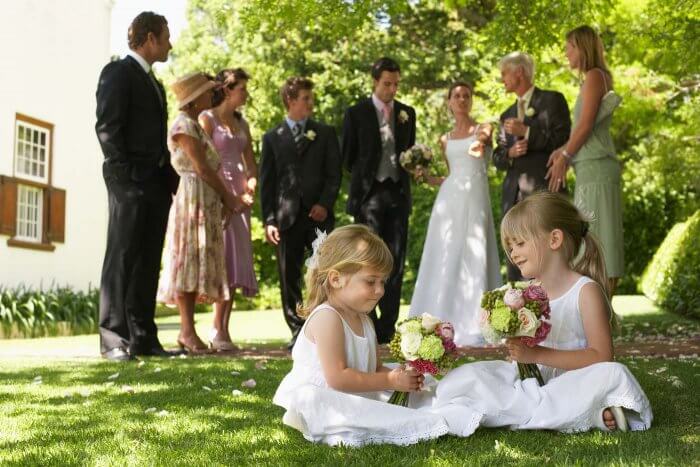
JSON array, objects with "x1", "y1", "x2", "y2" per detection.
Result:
[{"x1": 409, "y1": 136, "x2": 502, "y2": 346}]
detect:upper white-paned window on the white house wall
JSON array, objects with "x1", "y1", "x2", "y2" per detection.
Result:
[{"x1": 15, "y1": 115, "x2": 53, "y2": 184}]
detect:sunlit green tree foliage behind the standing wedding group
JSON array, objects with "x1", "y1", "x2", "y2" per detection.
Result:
[{"x1": 166, "y1": 0, "x2": 700, "y2": 306}]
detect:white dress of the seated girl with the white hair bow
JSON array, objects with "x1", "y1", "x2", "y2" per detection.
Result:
[{"x1": 273, "y1": 304, "x2": 481, "y2": 446}]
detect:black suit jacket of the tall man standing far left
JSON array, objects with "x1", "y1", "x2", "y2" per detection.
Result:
[{"x1": 95, "y1": 56, "x2": 178, "y2": 192}]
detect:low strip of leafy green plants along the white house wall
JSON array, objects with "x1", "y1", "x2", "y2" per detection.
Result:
[{"x1": 0, "y1": 286, "x2": 100, "y2": 337}]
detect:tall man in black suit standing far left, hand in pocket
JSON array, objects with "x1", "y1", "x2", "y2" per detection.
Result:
[{"x1": 95, "y1": 12, "x2": 178, "y2": 360}]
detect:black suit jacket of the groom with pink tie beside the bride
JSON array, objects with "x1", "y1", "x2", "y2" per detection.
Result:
[{"x1": 343, "y1": 97, "x2": 416, "y2": 216}]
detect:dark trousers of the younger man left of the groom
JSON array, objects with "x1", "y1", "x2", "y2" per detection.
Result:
[{"x1": 277, "y1": 208, "x2": 335, "y2": 343}]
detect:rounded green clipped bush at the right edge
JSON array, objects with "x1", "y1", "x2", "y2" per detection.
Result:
[{"x1": 642, "y1": 210, "x2": 700, "y2": 318}]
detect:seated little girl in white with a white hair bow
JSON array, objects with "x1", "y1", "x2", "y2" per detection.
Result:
[{"x1": 273, "y1": 225, "x2": 480, "y2": 446}]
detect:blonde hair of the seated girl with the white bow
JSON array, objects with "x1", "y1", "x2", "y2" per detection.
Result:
[{"x1": 297, "y1": 224, "x2": 394, "y2": 318}]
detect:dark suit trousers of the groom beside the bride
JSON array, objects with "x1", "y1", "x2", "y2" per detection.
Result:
[{"x1": 355, "y1": 179, "x2": 410, "y2": 344}]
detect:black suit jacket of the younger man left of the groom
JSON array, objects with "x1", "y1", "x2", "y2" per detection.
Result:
[{"x1": 260, "y1": 119, "x2": 342, "y2": 231}]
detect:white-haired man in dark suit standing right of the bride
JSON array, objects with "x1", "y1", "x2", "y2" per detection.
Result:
[{"x1": 493, "y1": 52, "x2": 571, "y2": 281}]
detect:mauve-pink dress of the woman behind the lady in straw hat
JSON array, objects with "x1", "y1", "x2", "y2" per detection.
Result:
[{"x1": 204, "y1": 110, "x2": 258, "y2": 297}]
